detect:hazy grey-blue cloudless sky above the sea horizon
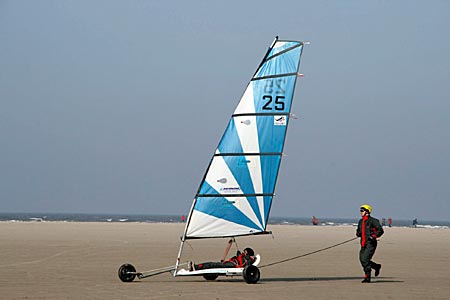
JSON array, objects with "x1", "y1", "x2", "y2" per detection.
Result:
[{"x1": 0, "y1": 0, "x2": 450, "y2": 221}]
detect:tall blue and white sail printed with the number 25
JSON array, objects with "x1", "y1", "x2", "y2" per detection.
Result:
[{"x1": 184, "y1": 39, "x2": 304, "y2": 239}]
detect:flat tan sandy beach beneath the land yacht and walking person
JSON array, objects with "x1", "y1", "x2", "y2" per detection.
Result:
[{"x1": 0, "y1": 222, "x2": 450, "y2": 300}]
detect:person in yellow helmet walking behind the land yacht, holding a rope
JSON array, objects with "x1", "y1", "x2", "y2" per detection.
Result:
[{"x1": 356, "y1": 204, "x2": 384, "y2": 283}]
